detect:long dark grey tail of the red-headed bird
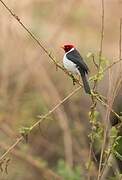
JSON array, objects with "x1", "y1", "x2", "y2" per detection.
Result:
[{"x1": 80, "y1": 70, "x2": 91, "y2": 94}]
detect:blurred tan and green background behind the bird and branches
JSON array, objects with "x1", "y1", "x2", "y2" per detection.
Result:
[{"x1": 0, "y1": 0, "x2": 122, "y2": 180}]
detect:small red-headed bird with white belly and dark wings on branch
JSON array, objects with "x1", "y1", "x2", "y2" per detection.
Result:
[{"x1": 61, "y1": 44, "x2": 91, "y2": 94}]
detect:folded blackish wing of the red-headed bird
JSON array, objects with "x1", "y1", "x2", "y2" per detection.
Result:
[{"x1": 66, "y1": 49, "x2": 89, "y2": 74}]
